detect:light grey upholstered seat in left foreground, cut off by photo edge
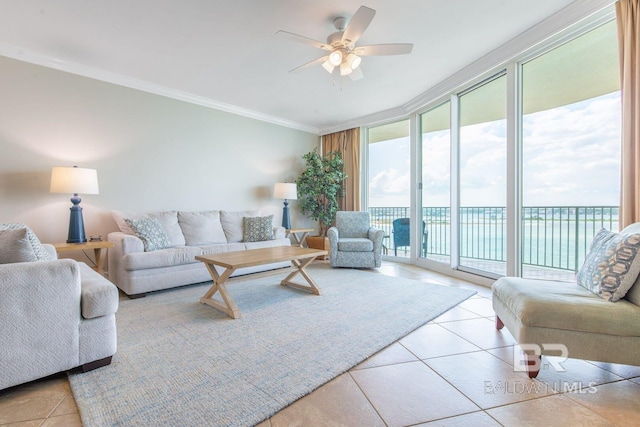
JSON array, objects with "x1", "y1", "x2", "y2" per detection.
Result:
[{"x1": 0, "y1": 237, "x2": 118, "y2": 390}]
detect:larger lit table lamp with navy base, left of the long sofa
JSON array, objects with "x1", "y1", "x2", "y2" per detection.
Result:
[{"x1": 49, "y1": 166, "x2": 98, "y2": 243}]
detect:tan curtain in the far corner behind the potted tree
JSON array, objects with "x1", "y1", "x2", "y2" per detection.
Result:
[{"x1": 322, "y1": 128, "x2": 360, "y2": 211}]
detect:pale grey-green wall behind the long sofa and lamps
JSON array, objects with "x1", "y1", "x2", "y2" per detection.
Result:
[{"x1": 0, "y1": 57, "x2": 319, "y2": 252}]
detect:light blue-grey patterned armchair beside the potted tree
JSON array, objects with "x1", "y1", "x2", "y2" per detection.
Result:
[{"x1": 327, "y1": 211, "x2": 384, "y2": 268}]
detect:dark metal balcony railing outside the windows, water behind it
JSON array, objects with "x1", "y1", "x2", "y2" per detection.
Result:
[{"x1": 369, "y1": 206, "x2": 619, "y2": 272}]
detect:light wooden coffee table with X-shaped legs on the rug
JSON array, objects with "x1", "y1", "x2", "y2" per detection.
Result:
[{"x1": 196, "y1": 246, "x2": 327, "y2": 319}]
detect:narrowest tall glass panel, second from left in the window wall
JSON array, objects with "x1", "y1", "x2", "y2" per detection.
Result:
[{"x1": 419, "y1": 101, "x2": 451, "y2": 264}]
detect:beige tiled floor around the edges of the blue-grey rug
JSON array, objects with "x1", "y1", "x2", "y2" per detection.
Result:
[{"x1": 0, "y1": 262, "x2": 640, "y2": 427}]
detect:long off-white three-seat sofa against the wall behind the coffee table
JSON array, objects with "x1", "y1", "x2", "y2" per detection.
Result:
[{"x1": 108, "y1": 210, "x2": 291, "y2": 298}]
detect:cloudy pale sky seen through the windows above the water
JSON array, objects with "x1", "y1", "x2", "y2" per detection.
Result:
[{"x1": 369, "y1": 92, "x2": 620, "y2": 207}]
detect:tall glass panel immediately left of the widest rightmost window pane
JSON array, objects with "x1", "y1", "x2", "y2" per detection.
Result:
[{"x1": 458, "y1": 74, "x2": 507, "y2": 275}]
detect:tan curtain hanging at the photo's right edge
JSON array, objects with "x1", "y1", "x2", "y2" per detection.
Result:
[{"x1": 616, "y1": 0, "x2": 640, "y2": 228}]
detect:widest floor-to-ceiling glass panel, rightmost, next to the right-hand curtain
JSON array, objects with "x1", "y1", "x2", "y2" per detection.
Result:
[{"x1": 521, "y1": 21, "x2": 620, "y2": 280}]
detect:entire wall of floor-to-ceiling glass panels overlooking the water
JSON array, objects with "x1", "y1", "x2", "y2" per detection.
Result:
[{"x1": 367, "y1": 12, "x2": 620, "y2": 279}]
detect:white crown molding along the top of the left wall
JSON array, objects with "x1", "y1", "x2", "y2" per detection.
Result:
[{"x1": 0, "y1": 43, "x2": 320, "y2": 135}]
